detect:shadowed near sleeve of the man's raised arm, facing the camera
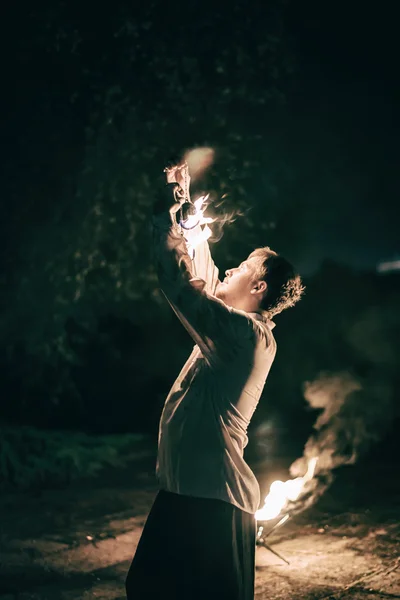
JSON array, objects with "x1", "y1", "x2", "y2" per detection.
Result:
[{"x1": 153, "y1": 214, "x2": 254, "y2": 364}]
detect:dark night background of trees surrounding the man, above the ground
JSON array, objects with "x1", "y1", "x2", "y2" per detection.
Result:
[{"x1": 0, "y1": 0, "x2": 400, "y2": 486}]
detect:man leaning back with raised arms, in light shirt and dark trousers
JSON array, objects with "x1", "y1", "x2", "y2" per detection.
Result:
[{"x1": 126, "y1": 165, "x2": 304, "y2": 600}]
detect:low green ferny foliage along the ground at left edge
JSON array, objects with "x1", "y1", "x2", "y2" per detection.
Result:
[{"x1": 0, "y1": 426, "x2": 148, "y2": 489}]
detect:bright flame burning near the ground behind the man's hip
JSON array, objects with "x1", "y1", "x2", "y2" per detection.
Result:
[{"x1": 255, "y1": 457, "x2": 318, "y2": 521}]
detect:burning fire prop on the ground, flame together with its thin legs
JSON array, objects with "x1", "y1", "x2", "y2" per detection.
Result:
[{"x1": 255, "y1": 458, "x2": 318, "y2": 564}]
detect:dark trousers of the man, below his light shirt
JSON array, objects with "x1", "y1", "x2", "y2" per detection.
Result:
[{"x1": 126, "y1": 491, "x2": 256, "y2": 600}]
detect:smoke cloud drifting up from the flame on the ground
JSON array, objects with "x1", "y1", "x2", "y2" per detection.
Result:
[{"x1": 290, "y1": 372, "x2": 394, "y2": 512}]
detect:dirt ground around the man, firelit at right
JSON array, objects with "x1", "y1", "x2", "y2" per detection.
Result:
[{"x1": 0, "y1": 442, "x2": 400, "y2": 600}]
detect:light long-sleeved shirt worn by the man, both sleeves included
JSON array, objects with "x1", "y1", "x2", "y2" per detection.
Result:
[{"x1": 155, "y1": 215, "x2": 276, "y2": 513}]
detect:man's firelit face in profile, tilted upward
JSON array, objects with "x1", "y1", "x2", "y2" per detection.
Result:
[{"x1": 215, "y1": 257, "x2": 260, "y2": 308}]
